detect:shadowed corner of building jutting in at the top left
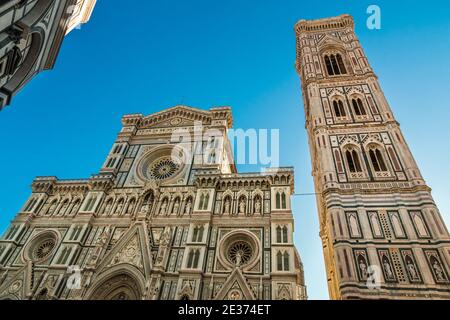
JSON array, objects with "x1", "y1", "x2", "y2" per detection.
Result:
[{"x1": 0, "y1": 0, "x2": 96, "y2": 110}]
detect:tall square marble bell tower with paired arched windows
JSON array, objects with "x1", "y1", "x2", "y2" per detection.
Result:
[{"x1": 295, "y1": 15, "x2": 450, "y2": 299}]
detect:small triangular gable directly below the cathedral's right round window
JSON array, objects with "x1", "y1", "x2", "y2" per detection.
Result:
[{"x1": 214, "y1": 268, "x2": 256, "y2": 300}]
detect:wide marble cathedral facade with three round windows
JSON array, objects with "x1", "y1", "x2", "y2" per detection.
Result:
[{"x1": 0, "y1": 106, "x2": 306, "y2": 300}]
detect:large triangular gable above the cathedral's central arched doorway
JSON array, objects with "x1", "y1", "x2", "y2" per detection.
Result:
[{"x1": 98, "y1": 222, "x2": 152, "y2": 276}]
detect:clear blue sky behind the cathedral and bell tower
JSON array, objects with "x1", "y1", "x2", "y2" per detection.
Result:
[{"x1": 0, "y1": 0, "x2": 450, "y2": 299}]
